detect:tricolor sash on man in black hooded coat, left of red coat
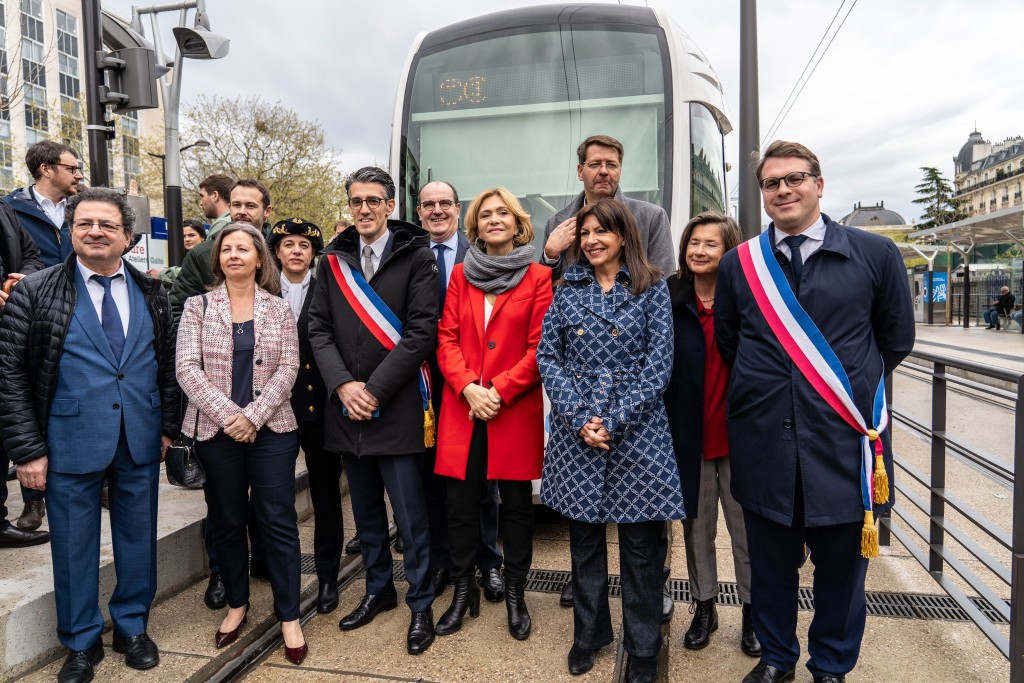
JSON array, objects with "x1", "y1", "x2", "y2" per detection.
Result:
[{"x1": 327, "y1": 254, "x2": 435, "y2": 447}]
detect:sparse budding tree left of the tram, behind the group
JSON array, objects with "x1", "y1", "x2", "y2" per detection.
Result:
[{"x1": 144, "y1": 95, "x2": 346, "y2": 240}]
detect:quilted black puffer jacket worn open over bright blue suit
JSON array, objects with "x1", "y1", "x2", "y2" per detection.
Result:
[{"x1": 0, "y1": 254, "x2": 181, "y2": 464}]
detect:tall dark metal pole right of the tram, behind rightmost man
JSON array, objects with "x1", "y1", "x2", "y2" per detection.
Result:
[{"x1": 738, "y1": 0, "x2": 761, "y2": 238}]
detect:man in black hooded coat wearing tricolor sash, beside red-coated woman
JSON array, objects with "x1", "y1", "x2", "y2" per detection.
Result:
[{"x1": 309, "y1": 167, "x2": 438, "y2": 654}]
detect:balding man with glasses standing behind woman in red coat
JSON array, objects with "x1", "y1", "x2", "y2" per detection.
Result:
[{"x1": 416, "y1": 180, "x2": 505, "y2": 602}]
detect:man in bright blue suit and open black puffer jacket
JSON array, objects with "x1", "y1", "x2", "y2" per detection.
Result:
[{"x1": 0, "y1": 188, "x2": 179, "y2": 683}]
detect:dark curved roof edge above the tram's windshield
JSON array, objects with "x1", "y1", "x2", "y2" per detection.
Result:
[{"x1": 420, "y1": 3, "x2": 659, "y2": 49}]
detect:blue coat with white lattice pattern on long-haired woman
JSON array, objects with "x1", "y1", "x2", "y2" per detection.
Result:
[{"x1": 537, "y1": 264, "x2": 685, "y2": 522}]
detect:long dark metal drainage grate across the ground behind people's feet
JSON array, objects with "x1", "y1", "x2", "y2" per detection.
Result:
[{"x1": 317, "y1": 554, "x2": 1009, "y2": 624}]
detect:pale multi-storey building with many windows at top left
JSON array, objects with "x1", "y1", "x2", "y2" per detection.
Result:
[{"x1": 0, "y1": 0, "x2": 163, "y2": 195}]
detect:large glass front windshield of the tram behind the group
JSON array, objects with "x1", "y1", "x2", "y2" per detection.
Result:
[{"x1": 400, "y1": 28, "x2": 671, "y2": 244}]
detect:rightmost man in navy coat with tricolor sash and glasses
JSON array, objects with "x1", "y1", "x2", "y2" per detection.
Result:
[{"x1": 715, "y1": 141, "x2": 914, "y2": 683}]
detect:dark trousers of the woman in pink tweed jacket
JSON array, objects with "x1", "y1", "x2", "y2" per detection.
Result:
[{"x1": 197, "y1": 427, "x2": 301, "y2": 622}]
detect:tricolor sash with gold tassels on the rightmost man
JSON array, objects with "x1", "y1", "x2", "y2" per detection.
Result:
[{"x1": 737, "y1": 230, "x2": 889, "y2": 557}]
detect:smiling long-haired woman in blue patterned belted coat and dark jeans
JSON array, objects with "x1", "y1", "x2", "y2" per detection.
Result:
[{"x1": 537, "y1": 200, "x2": 684, "y2": 681}]
